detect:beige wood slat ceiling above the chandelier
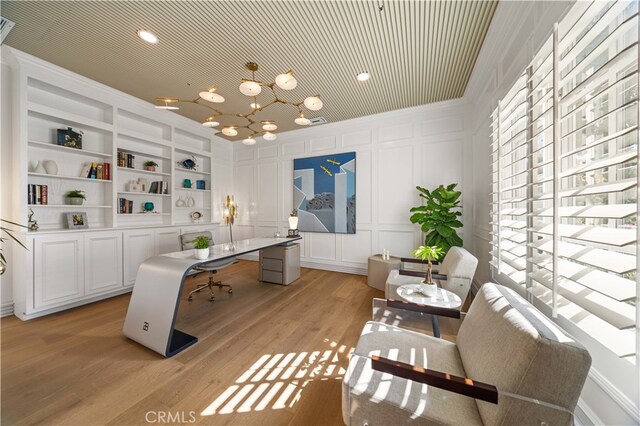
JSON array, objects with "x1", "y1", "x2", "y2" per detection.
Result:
[{"x1": 1, "y1": 0, "x2": 497, "y2": 139}]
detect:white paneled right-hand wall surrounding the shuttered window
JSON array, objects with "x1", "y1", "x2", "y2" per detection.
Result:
[{"x1": 464, "y1": 1, "x2": 640, "y2": 425}]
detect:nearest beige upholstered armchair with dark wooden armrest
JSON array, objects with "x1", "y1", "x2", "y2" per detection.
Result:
[{"x1": 342, "y1": 283, "x2": 591, "y2": 426}]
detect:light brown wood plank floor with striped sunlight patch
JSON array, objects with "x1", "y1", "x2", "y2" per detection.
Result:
[{"x1": 1, "y1": 261, "x2": 383, "y2": 425}]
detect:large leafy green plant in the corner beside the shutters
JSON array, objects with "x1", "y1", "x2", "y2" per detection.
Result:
[{"x1": 410, "y1": 183, "x2": 462, "y2": 255}]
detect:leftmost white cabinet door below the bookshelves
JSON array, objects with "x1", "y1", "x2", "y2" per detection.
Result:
[{"x1": 33, "y1": 233, "x2": 84, "y2": 309}]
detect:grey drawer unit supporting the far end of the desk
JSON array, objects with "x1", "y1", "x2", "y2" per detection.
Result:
[{"x1": 260, "y1": 244, "x2": 300, "y2": 285}]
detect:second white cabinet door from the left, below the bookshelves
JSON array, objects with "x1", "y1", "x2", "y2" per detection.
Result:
[{"x1": 84, "y1": 231, "x2": 122, "y2": 295}]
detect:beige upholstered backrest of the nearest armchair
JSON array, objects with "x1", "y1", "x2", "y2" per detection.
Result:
[{"x1": 457, "y1": 284, "x2": 591, "y2": 424}]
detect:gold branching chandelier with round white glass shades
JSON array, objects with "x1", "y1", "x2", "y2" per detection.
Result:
[{"x1": 156, "y1": 62, "x2": 322, "y2": 145}]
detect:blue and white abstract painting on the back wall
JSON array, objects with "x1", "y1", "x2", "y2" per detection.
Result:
[{"x1": 293, "y1": 152, "x2": 356, "y2": 234}]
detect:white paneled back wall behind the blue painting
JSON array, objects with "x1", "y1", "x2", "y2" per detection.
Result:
[{"x1": 234, "y1": 101, "x2": 466, "y2": 274}]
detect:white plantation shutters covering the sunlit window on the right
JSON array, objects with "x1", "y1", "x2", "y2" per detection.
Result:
[{"x1": 491, "y1": 1, "x2": 640, "y2": 363}]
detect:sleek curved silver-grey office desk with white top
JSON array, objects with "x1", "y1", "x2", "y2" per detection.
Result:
[{"x1": 122, "y1": 237, "x2": 302, "y2": 357}]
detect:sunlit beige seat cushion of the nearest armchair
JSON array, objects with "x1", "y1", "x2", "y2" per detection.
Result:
[{"x1": 342, "y1": 321, "x2": 482, "y2": 425}]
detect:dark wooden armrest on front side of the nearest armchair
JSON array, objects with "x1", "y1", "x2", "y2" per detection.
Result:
[{"x1": 371, "y1": 355, "x2": 498, "y2": 404}]
